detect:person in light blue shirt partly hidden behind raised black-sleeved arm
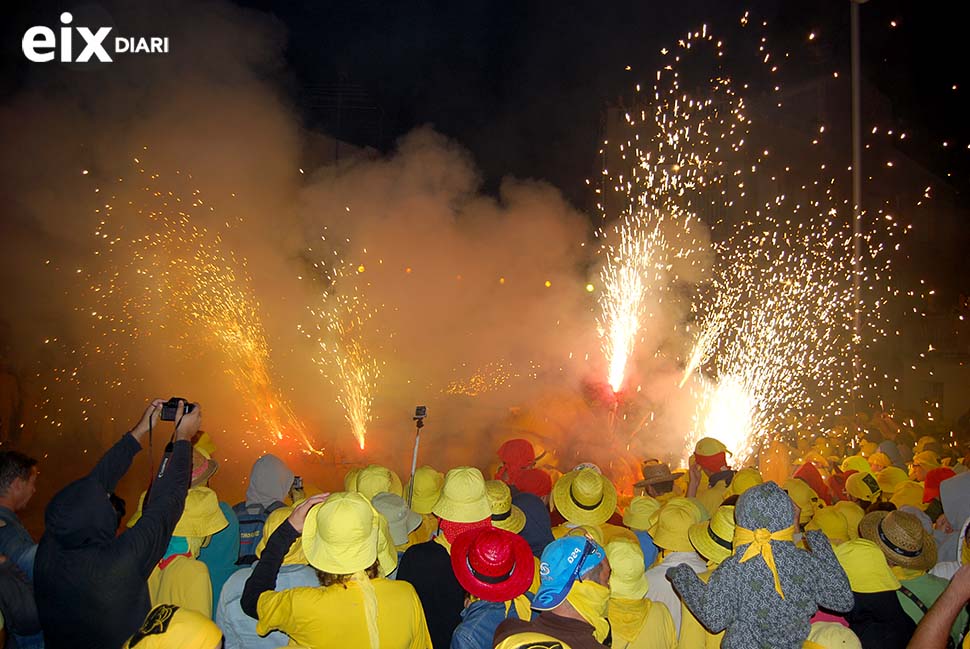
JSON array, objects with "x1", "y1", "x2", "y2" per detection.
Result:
[{"x1": 216, "y1": 507, "x2": 320, "y2": 649}]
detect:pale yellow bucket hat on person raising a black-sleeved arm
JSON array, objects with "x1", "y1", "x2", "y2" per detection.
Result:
[{"x1": 302, "y1": 492, "x2": 380, "y2": 575}]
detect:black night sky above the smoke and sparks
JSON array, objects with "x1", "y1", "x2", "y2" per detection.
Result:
[{"x1": 7, "y1": 0, "x2": 970, "y2": 208}]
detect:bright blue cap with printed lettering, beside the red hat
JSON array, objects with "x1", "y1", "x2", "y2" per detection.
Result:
[{"x1": 532, "y1": 536, "x2": 606, "y2": 611}]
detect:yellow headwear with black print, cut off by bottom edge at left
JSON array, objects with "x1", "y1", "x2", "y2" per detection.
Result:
[{"x1": 122, "y1": 604, "x2": 222, "y2": 649}]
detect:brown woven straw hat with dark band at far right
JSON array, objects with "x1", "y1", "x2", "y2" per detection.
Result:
[{"x1": 859, "y1": 511, "x2": 936, "y2": 570}]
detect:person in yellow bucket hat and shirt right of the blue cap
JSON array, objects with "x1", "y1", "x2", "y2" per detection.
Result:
[{"x1": 606, "y1": 539, "x2": 677, "y2": 649}]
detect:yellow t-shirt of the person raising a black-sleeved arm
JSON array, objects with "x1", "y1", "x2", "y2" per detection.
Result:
[{"x1": 256, "y1": 577, "x2": 431, "y2": 649}]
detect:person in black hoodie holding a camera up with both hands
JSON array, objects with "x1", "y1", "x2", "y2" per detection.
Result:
[{"x1": 34, "y1": 399, "x2": 202, "y2": 649}]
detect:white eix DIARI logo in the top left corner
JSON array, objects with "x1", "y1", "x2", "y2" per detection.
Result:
[{"x1": 21, "y1": 11, "x2": 168, "y2": 63}]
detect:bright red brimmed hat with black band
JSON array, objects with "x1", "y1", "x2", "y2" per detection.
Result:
[{"x1": 451, "y1": 527, "x2": 536, "y2": 602}]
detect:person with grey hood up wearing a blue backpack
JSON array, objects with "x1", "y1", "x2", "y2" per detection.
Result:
[{"x1": 232, "y1": 453, "x2": 295, "y2": 566}]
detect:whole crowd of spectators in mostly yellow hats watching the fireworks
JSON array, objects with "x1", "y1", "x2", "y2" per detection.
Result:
[{"x1": 0, "y1": 400, "x2": 970, "y2": 649}]
